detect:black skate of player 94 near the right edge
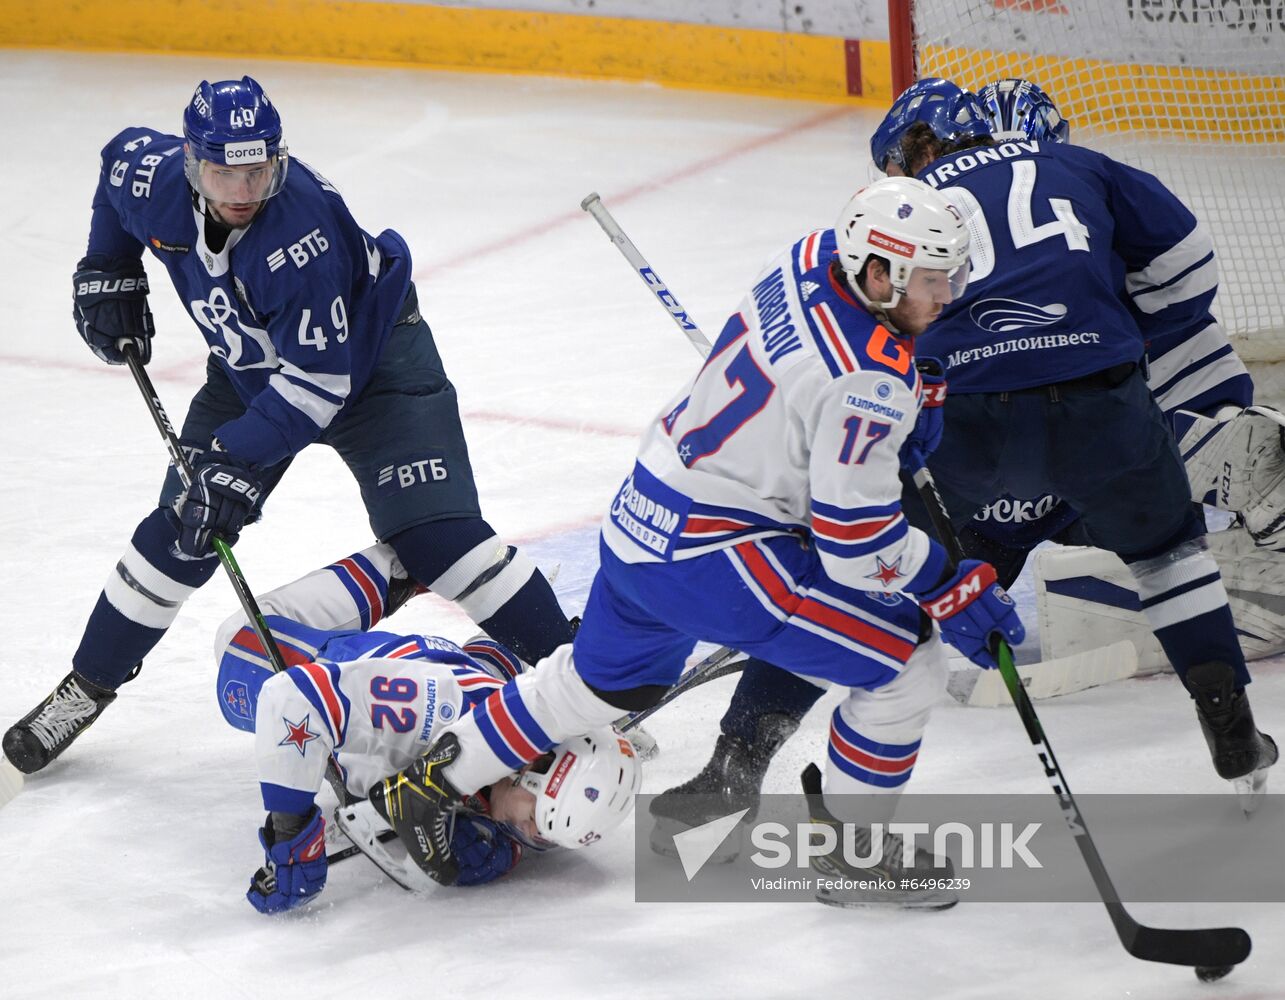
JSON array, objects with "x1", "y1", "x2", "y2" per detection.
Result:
[{"x1": 1186, "y1": 662, "x2": 1280, "y2": 816}]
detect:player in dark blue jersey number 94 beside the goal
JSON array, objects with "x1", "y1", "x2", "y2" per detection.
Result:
[{"x1": 902, "y1": 97, "x2": 1280, "y2": 788}]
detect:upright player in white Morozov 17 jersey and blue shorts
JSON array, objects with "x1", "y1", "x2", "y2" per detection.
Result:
[{"x1": 349, "y1": 179, "x2": 1023, "y2": 907}]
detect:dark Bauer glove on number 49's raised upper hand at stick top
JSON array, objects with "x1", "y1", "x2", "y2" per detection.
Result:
[{"x1": 72, "y1": 256, "x2": 155, "y2": 365}]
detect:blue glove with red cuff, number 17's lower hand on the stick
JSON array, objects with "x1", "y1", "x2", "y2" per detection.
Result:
[{"x1": 919, "y1": 559, "x2": 1027, "y2": 670}]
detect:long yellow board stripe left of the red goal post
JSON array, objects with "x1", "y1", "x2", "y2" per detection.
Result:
[{"x1": 0, "y1": 0, "x2": 893, "y2": 105}]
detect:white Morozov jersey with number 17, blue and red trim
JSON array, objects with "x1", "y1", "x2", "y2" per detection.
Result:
[{"x1": 603, "y1": 230, "x2": 941, "y2": 591}]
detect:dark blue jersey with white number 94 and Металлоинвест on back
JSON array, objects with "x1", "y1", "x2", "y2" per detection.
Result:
[{"x1": 916, "y1": 140, "x2": 1218, "y2": 393}]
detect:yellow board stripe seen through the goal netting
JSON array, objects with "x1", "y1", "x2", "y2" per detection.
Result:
[{"x1": 919, "y1": 45, "x2": 1285, "y2": 144}]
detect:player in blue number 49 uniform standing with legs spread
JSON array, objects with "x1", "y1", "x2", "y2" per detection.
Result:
[{"x1": 4, "y1": 77, "x2": 572, "y2": 774}]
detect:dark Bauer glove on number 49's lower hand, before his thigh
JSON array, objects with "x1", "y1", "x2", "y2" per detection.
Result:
[{"x1": 175, "y1": 451, "x2": 263, "y2": 559}]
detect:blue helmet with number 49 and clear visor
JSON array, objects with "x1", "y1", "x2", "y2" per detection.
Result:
[{"x1": 182, "y1": 76, "x2": 289, "y2": 204}]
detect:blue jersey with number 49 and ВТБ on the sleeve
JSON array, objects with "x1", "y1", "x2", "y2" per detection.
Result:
[{"x1": 89, "y1": 129, "x2": 411, "y2": 467}]
